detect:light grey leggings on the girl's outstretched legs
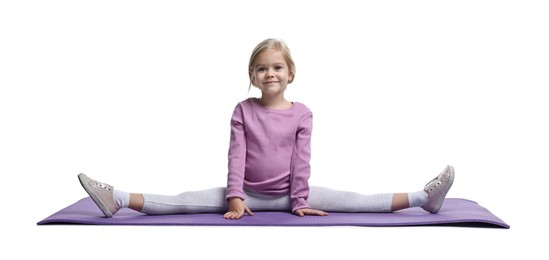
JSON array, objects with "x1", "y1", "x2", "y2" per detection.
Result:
[{"x1": 141, "y1": 186, "x2": 393, "y2": 215}]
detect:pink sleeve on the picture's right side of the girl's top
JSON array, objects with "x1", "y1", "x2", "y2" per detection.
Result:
[{"x1": 290, "y1": 112, "x2": 313, "y2": 212}]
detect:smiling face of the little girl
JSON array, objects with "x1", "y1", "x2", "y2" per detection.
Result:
[{"x1": 250, "y1": 50, "x2": 293, "y2": 95}]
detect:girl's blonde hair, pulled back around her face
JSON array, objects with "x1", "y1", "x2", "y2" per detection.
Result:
[{"x1": 248, "y1": 38, "x2": 295, "y2": 91}]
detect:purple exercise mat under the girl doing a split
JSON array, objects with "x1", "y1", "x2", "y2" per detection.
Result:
[{"x1": 37, "y1": 197, "x2": 510, "y2": 228}]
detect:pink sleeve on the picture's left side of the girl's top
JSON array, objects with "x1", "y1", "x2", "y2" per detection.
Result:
[{"x1": 225, "y1": 104, "x2": 246, "y2": 199}]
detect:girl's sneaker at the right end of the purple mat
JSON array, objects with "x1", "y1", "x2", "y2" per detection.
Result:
[{"x1": 421, "y1": 165, "x2": 455, "y2": 214}]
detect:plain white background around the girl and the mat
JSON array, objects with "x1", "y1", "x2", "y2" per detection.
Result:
[{"x1": 0, "y1": 0, "x2": 549, "y2": 259}]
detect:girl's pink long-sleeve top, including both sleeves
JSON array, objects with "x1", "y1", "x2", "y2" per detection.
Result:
[{"x1": 226, "y1": 98, "x2": 313, "y2": 211}]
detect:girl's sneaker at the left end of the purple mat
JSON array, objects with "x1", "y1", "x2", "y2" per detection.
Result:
[{"x1": 78, "y1": 173, "x2": 120, "y2": 218}]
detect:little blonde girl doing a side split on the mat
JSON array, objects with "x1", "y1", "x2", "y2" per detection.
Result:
[{"x1": 78, "y1": 39, "x2": 454, "y2": 219}]
